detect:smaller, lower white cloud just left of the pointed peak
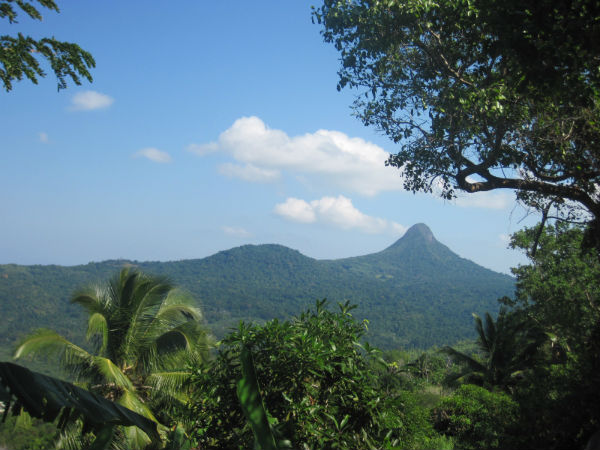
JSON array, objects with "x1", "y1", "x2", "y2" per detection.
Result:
[{"x1": 274, "y1": 195, "x2": 406, "y2": 234}]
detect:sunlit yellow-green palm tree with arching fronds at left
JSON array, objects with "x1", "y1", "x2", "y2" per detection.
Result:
[{"x1": 15, "y1": 268, "x2": 210, "y2": 448}]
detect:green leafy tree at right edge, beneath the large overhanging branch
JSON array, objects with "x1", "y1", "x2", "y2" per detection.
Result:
[{"x1": 510, "y1": 223, "x2": 600, "y2": 353}]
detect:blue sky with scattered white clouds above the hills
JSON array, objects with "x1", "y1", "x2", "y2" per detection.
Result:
[{"x1": 0, "y1": 0, "x2": 534, "y2": 273}]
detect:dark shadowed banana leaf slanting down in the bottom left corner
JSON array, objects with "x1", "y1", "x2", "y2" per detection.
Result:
[{"x1": 0, "y1": 362, "x2": 160, "y2": 442}]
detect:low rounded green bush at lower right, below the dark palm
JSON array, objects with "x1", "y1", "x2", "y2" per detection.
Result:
[{"x1": 432, "y1": 384, "x2": 519, "y2": 450}]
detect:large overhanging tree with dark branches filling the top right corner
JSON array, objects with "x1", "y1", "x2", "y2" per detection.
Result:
[{"x1": 314, "y1": 0, "x2": 600, "y2": 243}]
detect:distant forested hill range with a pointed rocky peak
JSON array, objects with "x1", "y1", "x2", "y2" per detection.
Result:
[{"x1": 0, "y1": 224, "x2": 514, "y2": 356}]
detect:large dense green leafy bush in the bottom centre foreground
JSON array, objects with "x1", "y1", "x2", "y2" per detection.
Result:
[{"x1": 185, "y1": 302, "x2": 435, "y2": 449}]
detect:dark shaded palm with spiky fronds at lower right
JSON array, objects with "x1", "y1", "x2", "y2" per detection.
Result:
[{"x1": 442, "y1": 308, "x2": 544, "y2": 391}]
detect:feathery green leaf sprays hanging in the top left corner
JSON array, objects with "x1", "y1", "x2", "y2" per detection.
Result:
[{"x1": 0, "y1": 0, "x2": 96, "y2": 92}]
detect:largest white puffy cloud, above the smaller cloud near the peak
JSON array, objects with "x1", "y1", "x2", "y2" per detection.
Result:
[{"x1": 188, "y1": 117, "x2": 402, "y2": 196}]
